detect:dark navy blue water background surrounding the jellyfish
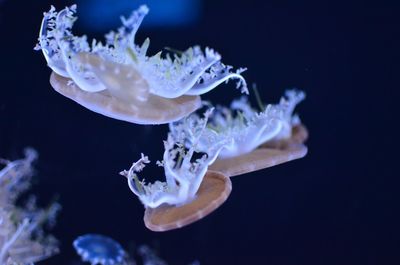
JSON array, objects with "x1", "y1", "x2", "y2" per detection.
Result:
[{"x1": 0, "y1": 0, "x2": 400, "y2": 265}]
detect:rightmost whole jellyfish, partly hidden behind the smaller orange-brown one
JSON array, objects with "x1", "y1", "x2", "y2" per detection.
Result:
[{"x1": 170, "y1": 90, "x2": 308, "y2": 177}]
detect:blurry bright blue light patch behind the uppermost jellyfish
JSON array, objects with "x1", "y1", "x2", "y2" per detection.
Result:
[{"x1": 76, "y1": 0, "x2": 202, "y2": 32}]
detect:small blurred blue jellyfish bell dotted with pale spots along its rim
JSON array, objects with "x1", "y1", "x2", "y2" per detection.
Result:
[{"x1": 73, "y1": 234, "x2": 125, "y2": 265}]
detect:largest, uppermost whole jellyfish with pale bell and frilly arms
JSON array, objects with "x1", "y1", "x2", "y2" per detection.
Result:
[{"x1": 35, "y1": 5, "x2": 248, "y2": 124}]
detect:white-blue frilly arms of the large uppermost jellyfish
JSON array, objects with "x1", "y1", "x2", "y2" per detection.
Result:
[{"x1": 35, "y1": 5, "x2": 248, "y2": 98}]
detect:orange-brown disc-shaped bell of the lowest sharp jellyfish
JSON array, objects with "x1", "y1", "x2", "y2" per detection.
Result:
[{"x1": 144, "y1": 171, "x2": 232, "y2": 232}]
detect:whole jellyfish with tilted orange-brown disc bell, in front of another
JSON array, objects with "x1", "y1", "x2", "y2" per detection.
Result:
[{"x1": 121, "y1": 109, "x2": 232, "y2": 231}]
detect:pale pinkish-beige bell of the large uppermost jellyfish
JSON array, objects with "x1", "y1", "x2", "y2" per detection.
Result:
[{"x1": 50, "y1": 72, "x2": 201, "y2": 124}]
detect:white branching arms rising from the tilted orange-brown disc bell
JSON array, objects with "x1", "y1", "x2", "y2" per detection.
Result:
[{"x1": 120, "y1": 110, "x2": 227, "y2": 208}]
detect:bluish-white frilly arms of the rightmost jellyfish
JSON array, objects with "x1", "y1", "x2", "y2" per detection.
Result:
[{"x1": 169, "y1": 90, "x2": 305, "y2": 159}]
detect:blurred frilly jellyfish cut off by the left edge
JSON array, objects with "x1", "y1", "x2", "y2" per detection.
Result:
[{"x1": 0, "y1": 149, "x2": 60, "y2": 264}]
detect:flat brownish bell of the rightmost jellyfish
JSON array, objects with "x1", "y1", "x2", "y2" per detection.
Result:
[{"x1": 209, "y1": 125, "x2": 308, "y2": 177}]
